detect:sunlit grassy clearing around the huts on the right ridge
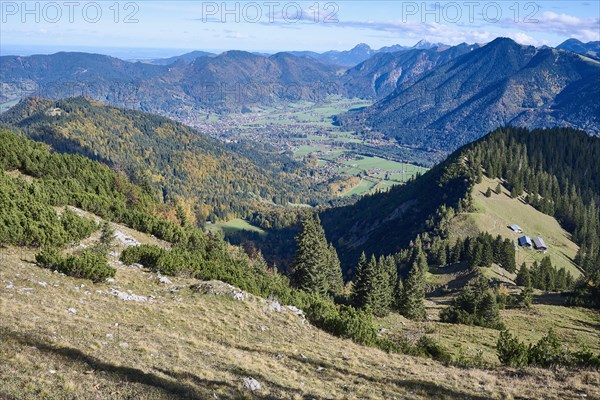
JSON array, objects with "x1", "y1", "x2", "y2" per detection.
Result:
[{"x1": 452, "y1": 177, "x2": 581, "y2": 277}]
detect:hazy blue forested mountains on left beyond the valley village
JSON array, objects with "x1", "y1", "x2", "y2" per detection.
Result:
[{"x1": 0, "y1": 51, "x2": 340, "y2": 115}]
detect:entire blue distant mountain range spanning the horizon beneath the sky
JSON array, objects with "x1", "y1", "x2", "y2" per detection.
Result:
[{"x1": 0, "y1": 38, "x2": 600, "y2": 151}]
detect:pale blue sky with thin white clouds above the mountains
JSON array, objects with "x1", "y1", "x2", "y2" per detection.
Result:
[{"x1": 0, "y1": 0, "x2": 600, "y2": 58}]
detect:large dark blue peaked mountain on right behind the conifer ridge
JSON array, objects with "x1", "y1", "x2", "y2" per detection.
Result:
[{"x1": 337, "y1": 38, "x2": 600, "y2": 151}]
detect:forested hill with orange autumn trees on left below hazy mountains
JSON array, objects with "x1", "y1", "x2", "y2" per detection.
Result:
[{"x1": 0, "y1": 98, "x2": 330, "y2": 221}]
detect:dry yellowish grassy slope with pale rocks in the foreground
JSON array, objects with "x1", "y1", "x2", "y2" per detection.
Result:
[{"x1": 0, "y1": 223, "x2": 600, "y2": 399}]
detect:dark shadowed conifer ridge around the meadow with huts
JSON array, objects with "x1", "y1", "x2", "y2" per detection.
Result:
[{"x1": 321, "y1": 128, "x2": 600, "y2": 270}]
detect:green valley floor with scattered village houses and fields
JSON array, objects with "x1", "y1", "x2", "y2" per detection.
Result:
[{"x1": 187, "y1": 96, "x2": 432, "y2": 196}]
